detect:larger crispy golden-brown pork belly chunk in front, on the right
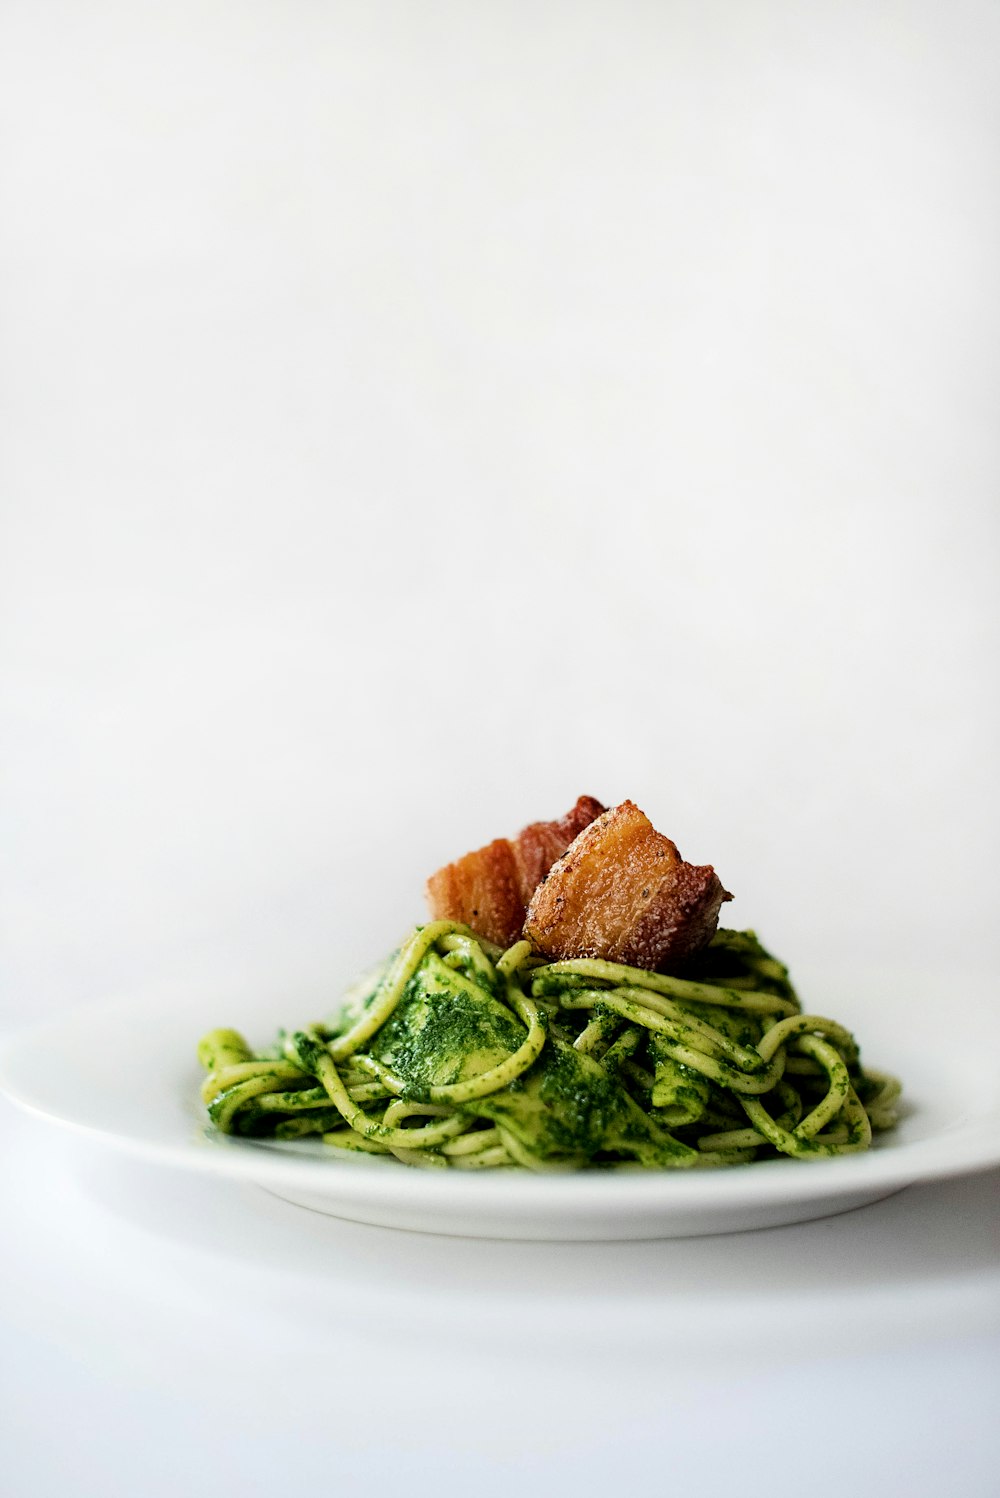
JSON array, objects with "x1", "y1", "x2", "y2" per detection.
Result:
[{"x1": 524, "y1": 801, "x2": 732, "y2": 971}]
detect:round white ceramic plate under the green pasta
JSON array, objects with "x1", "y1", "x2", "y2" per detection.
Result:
[{"x1": 0, "y1": 972, "x2": 1000, "y2": 1240}]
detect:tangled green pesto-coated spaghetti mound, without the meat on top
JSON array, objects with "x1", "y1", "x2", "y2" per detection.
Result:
[{"x1": 198, "y1": 921, "x2": 900, "y2": 1171}]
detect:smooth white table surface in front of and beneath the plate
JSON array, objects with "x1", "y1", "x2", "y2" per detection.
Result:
[{"x1": 0, "y1": 1106, "x2": 1000, "y2": 1498}]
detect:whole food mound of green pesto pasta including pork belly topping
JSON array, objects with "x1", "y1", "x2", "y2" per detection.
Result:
[{"x1": 198, "y1": 795, "x2": 900, "y2": 1171}]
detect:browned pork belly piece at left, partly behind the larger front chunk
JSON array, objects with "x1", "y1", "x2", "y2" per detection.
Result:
[{"x1": 427, "y1": 795, "x2": 605, "y2": 947}]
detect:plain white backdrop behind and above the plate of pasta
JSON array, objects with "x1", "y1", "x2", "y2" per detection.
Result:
[{"x1": 0, "y1": 0, "x2": 1000, "y2": 1494}]
